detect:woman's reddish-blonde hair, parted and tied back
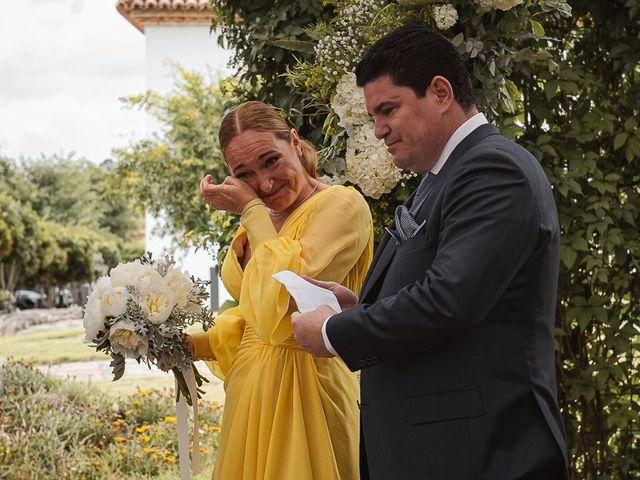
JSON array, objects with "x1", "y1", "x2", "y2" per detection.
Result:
[{"x1": 218, "y1": 100, "x2": 318, "y2": 178}]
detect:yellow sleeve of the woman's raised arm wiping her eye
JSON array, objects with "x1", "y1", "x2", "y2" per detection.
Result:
[{"x1": 239, "y1": 187, "x2": 372, "y2": 345}]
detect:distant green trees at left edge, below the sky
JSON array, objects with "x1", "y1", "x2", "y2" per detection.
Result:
[{"x1": 0, "y1": 156, "x2": 143, "y2": 306}]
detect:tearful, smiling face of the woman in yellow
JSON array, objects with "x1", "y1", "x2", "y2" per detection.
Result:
[{"x1": 224, "y1": 130, "x2": 310, "y2": 212}]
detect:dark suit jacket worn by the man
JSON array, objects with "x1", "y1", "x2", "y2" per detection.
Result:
[{"x1": 327, "y1": 125, "x2": 566, "y2": 480}]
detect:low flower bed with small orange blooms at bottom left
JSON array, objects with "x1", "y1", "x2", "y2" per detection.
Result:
[{"x1": 0, "y1": 362, "x2": 221, "y2": 480}]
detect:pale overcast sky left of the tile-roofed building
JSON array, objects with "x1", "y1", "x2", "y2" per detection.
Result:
[{"x1": 0, "y1": 0, "x2": 146, "y2": 163}]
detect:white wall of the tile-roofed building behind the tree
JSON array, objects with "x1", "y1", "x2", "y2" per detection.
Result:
[{"x1": 145, "y1": 26, "x2": 230, "y2": 303}]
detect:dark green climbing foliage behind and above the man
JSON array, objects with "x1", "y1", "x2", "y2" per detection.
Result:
[{"x1": 212, "y1": 0, "x2": 640, "y2": 480}]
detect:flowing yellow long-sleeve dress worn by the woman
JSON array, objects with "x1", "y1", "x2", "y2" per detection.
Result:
[{"x1": 193, "y1": 186, "x2": 373, "y2": 480}]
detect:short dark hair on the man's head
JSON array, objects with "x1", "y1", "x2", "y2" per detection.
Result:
[{"x1": 356, "y1": 25, "x2": 475, "y2": 111}]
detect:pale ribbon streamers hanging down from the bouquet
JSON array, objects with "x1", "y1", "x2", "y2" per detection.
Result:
[{"x1": 175, "y1": 368, "x2": 202, "y2": 480}]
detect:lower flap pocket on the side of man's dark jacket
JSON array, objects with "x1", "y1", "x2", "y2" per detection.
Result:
[{"x1": 402, "y1": 390, "x2": 484, "y2": 425}]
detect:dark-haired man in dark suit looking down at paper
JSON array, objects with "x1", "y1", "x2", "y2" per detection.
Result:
[{"x1": 292, "y1": 26, "x2": 567, "y2": 480}]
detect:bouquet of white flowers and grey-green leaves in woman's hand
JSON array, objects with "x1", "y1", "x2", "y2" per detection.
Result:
[{"x1": 83, "y1": 253, "x2": 213, "y2": 405}]
